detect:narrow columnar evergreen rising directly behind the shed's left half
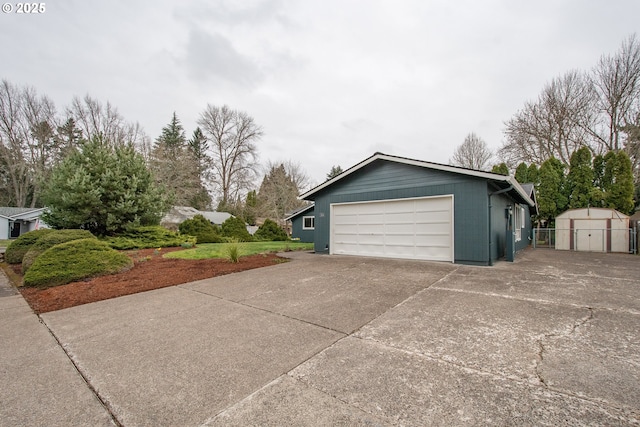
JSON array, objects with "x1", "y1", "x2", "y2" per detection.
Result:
[{"x1": 567, "y1": 147, "x2": 594, "y2": 209}]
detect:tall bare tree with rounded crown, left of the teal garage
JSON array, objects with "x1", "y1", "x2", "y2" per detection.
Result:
[{"x1": 198, "y1": 104, "x2": 262, "y2": 207}]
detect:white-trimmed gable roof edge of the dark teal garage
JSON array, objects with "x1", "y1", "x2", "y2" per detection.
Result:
[{"x1": 300, "y1": 153, "x2": 535, "y2": 206}]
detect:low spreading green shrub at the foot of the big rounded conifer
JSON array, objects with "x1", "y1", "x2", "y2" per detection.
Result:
[{"x1": 104, "y1": 225, "x2": 196, "y2": 250}]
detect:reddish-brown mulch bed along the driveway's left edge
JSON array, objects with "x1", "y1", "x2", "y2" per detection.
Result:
[{"x1": 14, "y1": 248, "x2": 285, "y2": 314}]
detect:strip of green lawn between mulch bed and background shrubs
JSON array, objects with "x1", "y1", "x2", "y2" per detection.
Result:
[{"x1": 165, "y1": 242, "x2": 313, "y2": 259}]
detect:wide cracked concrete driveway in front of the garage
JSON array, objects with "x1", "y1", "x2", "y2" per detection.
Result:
[{"x1": 0, "y1": 250, "x2": 640, "y2": 426}]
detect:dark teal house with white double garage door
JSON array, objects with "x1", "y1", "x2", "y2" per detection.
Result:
[{"x1": 301, "y1": 153, "x2": 537, "y2": 265}]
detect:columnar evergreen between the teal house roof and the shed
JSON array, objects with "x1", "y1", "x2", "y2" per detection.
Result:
[{"x1": 537, "y1": 157, "x2": 567, "y2": 224}]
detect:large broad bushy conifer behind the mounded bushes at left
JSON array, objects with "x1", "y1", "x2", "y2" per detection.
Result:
[{"x1": 42, "y1": 137, "x2": 169, "y2": 235}]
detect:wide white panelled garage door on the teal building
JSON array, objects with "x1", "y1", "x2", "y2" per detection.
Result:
[{"x1": 329, "y1": 195, "x2": 454, "y2": 262}]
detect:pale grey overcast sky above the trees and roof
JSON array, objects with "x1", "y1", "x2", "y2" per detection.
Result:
[{"x1": 0, "y1": 0, "x2": 640, "y2": 187}]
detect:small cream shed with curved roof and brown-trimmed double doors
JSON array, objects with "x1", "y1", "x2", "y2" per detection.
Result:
[{"x1": 556, "y1": 208, "x2": 629, "y2": 253}]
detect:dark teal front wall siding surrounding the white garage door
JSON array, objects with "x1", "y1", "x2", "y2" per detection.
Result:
[{"x1": 314, "y1": 161, "x2": 489, "y2": 265}]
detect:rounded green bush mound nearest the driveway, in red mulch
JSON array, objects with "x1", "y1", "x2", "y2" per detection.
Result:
[{"x1": 24, "y1": 238, "x2": 133, "y2": 288}]
